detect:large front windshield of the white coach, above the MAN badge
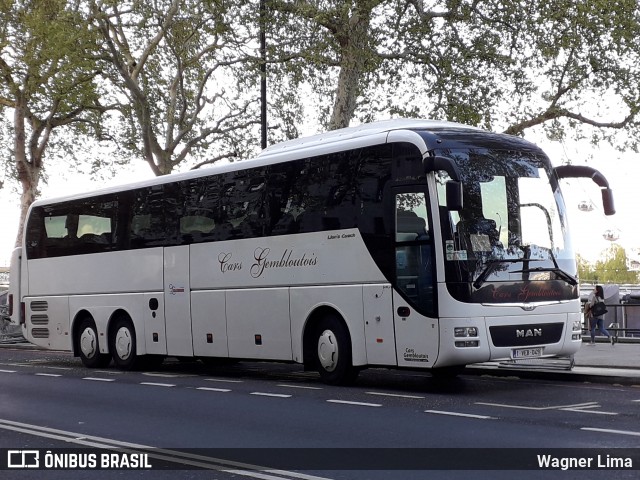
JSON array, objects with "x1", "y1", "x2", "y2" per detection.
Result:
[{"x1": 438, "y1": 148, "x2": 577, "y2": 303}]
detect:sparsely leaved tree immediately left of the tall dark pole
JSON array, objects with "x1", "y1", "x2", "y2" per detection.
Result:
[{"x1": 89, "y1": 0, "x2": 259, "y2": 175}]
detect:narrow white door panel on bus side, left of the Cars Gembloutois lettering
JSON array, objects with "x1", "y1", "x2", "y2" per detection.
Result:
[{"x1": 164, "y1": 245, "x2": 193, "y2": 357}]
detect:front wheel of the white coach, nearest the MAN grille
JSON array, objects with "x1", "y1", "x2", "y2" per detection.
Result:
[{"x1": 315, "y1": 315, "x2": 358, "y2": 385}]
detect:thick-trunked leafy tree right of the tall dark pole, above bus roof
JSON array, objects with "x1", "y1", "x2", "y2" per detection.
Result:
[{"x1": 267, "y1": 0, "x2": 640, "y2": 149}]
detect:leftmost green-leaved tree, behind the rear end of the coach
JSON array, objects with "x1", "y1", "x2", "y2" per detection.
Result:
[{"x1": 0, "y1": 0, "x2": 116, "y2": 244}]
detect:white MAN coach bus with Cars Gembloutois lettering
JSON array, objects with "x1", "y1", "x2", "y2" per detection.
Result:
[{"x1": 9, "y1": 120, "x2": 613, "y2": 384}]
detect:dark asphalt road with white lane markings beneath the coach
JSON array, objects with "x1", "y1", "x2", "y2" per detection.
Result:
[{"x1": 0, "y1": 349, "x2": 640, "y2": 480}]
